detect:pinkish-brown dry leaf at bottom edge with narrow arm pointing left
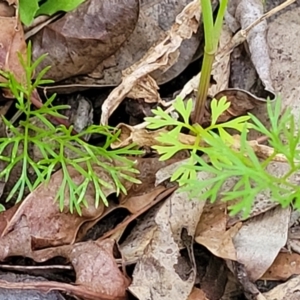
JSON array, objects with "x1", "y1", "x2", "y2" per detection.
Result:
[{"x1": 25, "y1": 240, "x2": 129, "y2": 299}]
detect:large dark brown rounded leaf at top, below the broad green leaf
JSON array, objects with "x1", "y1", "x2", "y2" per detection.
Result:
[{"x1": 32, "y1": 0, "x2": 139, "y2": 81}]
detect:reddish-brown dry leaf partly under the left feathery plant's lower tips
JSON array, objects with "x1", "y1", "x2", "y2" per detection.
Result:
[{"x1": 1, "y1": 167, "x2": 119, "y2": 251}]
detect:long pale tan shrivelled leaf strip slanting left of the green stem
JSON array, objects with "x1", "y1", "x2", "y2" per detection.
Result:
[{"x1": 101, "y1": 0, "x2": 200, "y2": 124}]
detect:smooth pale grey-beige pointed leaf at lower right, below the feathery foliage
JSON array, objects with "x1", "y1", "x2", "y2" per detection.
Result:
[{"x1": 233, "y1": 207, "x2": 290, "y2": 281}]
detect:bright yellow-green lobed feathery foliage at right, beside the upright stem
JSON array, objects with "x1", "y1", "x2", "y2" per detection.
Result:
[{"x1": 146, "y1": 98, "x2": 300, "y2": 217}]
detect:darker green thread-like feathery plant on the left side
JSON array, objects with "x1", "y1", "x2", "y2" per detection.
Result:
[{"x1": 0, "y1": 44, "x2": 142, "y2": 214}]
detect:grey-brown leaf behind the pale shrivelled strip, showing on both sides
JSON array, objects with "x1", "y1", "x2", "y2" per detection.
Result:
[{"x1": 52, "y1": 0, "x2": 202, "y2": 92}]
